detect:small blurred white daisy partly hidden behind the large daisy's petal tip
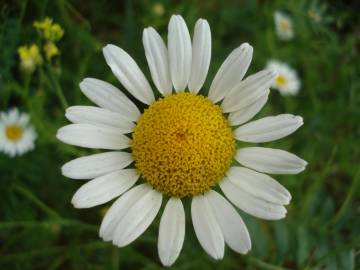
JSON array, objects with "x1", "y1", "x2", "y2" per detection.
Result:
[{"x1": 267, "y1": 60, "x2": 301, "y2": 96}]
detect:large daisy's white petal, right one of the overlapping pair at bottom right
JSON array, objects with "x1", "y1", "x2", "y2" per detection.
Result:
[{"x1": 205, "y1": 190, "x2": 251, "y2": 254}]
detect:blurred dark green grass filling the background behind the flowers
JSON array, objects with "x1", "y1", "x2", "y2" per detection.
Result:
[{"x1": 0, "y1": 0, "x2": 360, "y2": 269}]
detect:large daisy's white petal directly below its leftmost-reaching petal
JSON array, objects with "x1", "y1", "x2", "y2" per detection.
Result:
[{"x1": 61, "y1": 152, "x2": 133, "y2": 179}]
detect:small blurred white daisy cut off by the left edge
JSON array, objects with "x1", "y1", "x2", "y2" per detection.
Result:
[{"x1": 0, "y1": 108, "x2": 36, "y2": 157}]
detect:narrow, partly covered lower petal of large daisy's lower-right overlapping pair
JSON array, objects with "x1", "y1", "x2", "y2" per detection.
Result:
[{"x1": 220, "y1": 178, "x2": 286, "y2": 220}]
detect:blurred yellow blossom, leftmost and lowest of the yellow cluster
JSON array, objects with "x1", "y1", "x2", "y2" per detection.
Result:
[{"x1": 18, "y1": 44, "x2": 42, "y2": 73}]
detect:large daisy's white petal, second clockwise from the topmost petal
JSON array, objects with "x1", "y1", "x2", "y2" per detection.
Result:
[{"x1": 209, "y1": 43, "x2": 253, "y2": 103}]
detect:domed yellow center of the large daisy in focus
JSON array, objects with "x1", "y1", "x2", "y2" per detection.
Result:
[{"x1": 132, "y1": 93, "x2": 235, "y2": 198}]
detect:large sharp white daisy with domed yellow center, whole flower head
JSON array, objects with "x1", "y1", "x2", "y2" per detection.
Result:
[{"x1": 57, "y1": 15, "x2": 306, "y2": 266}]
